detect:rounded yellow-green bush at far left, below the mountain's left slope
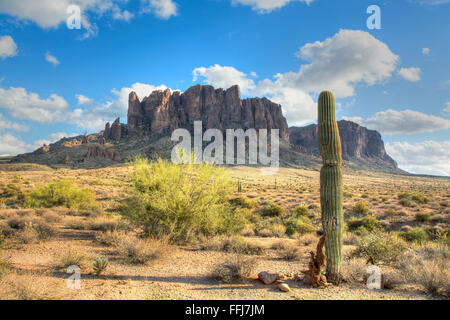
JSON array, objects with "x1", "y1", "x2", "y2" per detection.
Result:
[{"x1": 25, "y1": 180, "x2": 98, "y2": 211}]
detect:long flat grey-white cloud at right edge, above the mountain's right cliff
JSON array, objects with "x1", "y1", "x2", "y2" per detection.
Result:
[{"x1": 344, "y1": 109, "x2": 450, "y2": 134}]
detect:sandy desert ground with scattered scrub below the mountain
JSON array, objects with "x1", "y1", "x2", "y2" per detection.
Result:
[{"x1": 0, "y1": 164, "x2": 450, "y2": 300}]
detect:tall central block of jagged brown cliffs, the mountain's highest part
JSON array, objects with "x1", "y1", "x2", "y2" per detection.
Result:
[{"x1": 125, "y1": 85, "x2": 289, "y2": 141}]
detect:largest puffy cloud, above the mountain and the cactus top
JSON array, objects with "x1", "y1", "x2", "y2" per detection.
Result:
[{"x1": 193, "y1": 30, "x2": 399, "y2": 125}]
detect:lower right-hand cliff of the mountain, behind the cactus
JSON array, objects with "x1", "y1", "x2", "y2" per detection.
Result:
[{"x1": 289, "y1": 120, "x2": 397, "y2": 168}]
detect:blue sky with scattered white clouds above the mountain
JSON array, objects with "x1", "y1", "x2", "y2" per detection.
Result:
[{"x1": 0, "y1": 0, "x2": 450, "y2": 175}]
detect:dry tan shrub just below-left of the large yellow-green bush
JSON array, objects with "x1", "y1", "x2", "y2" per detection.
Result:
[{"x1": 117, "y1": 235, "x2": 170, "y2": 264}]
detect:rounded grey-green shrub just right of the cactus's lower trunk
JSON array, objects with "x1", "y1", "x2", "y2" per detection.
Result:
[{"x1": 352, "y1": 231, "x2": 405, "y2": 264}]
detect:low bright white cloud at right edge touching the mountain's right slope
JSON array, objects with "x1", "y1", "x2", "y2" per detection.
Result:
[{"x1": 386, "y1": 141, "x2": 450, "y2": 176}]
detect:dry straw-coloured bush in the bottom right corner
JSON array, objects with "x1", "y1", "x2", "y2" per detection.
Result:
[{"x1": 400, "y1": 246, "x2": 450, "y2": 297}]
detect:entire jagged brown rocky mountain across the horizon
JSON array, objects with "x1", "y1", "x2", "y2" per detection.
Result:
[{"x1": 8, "y1": 85, "x2": 401, "y2": 172}]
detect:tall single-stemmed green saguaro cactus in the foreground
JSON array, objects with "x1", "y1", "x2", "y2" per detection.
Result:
[{"x1": 318, "y1": 91, "x2": 344, "y2": 284}]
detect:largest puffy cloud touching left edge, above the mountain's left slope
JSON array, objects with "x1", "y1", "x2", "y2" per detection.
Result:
[{"x1": 0, "y1": 87, "x2": 69, "y2": 123}]
